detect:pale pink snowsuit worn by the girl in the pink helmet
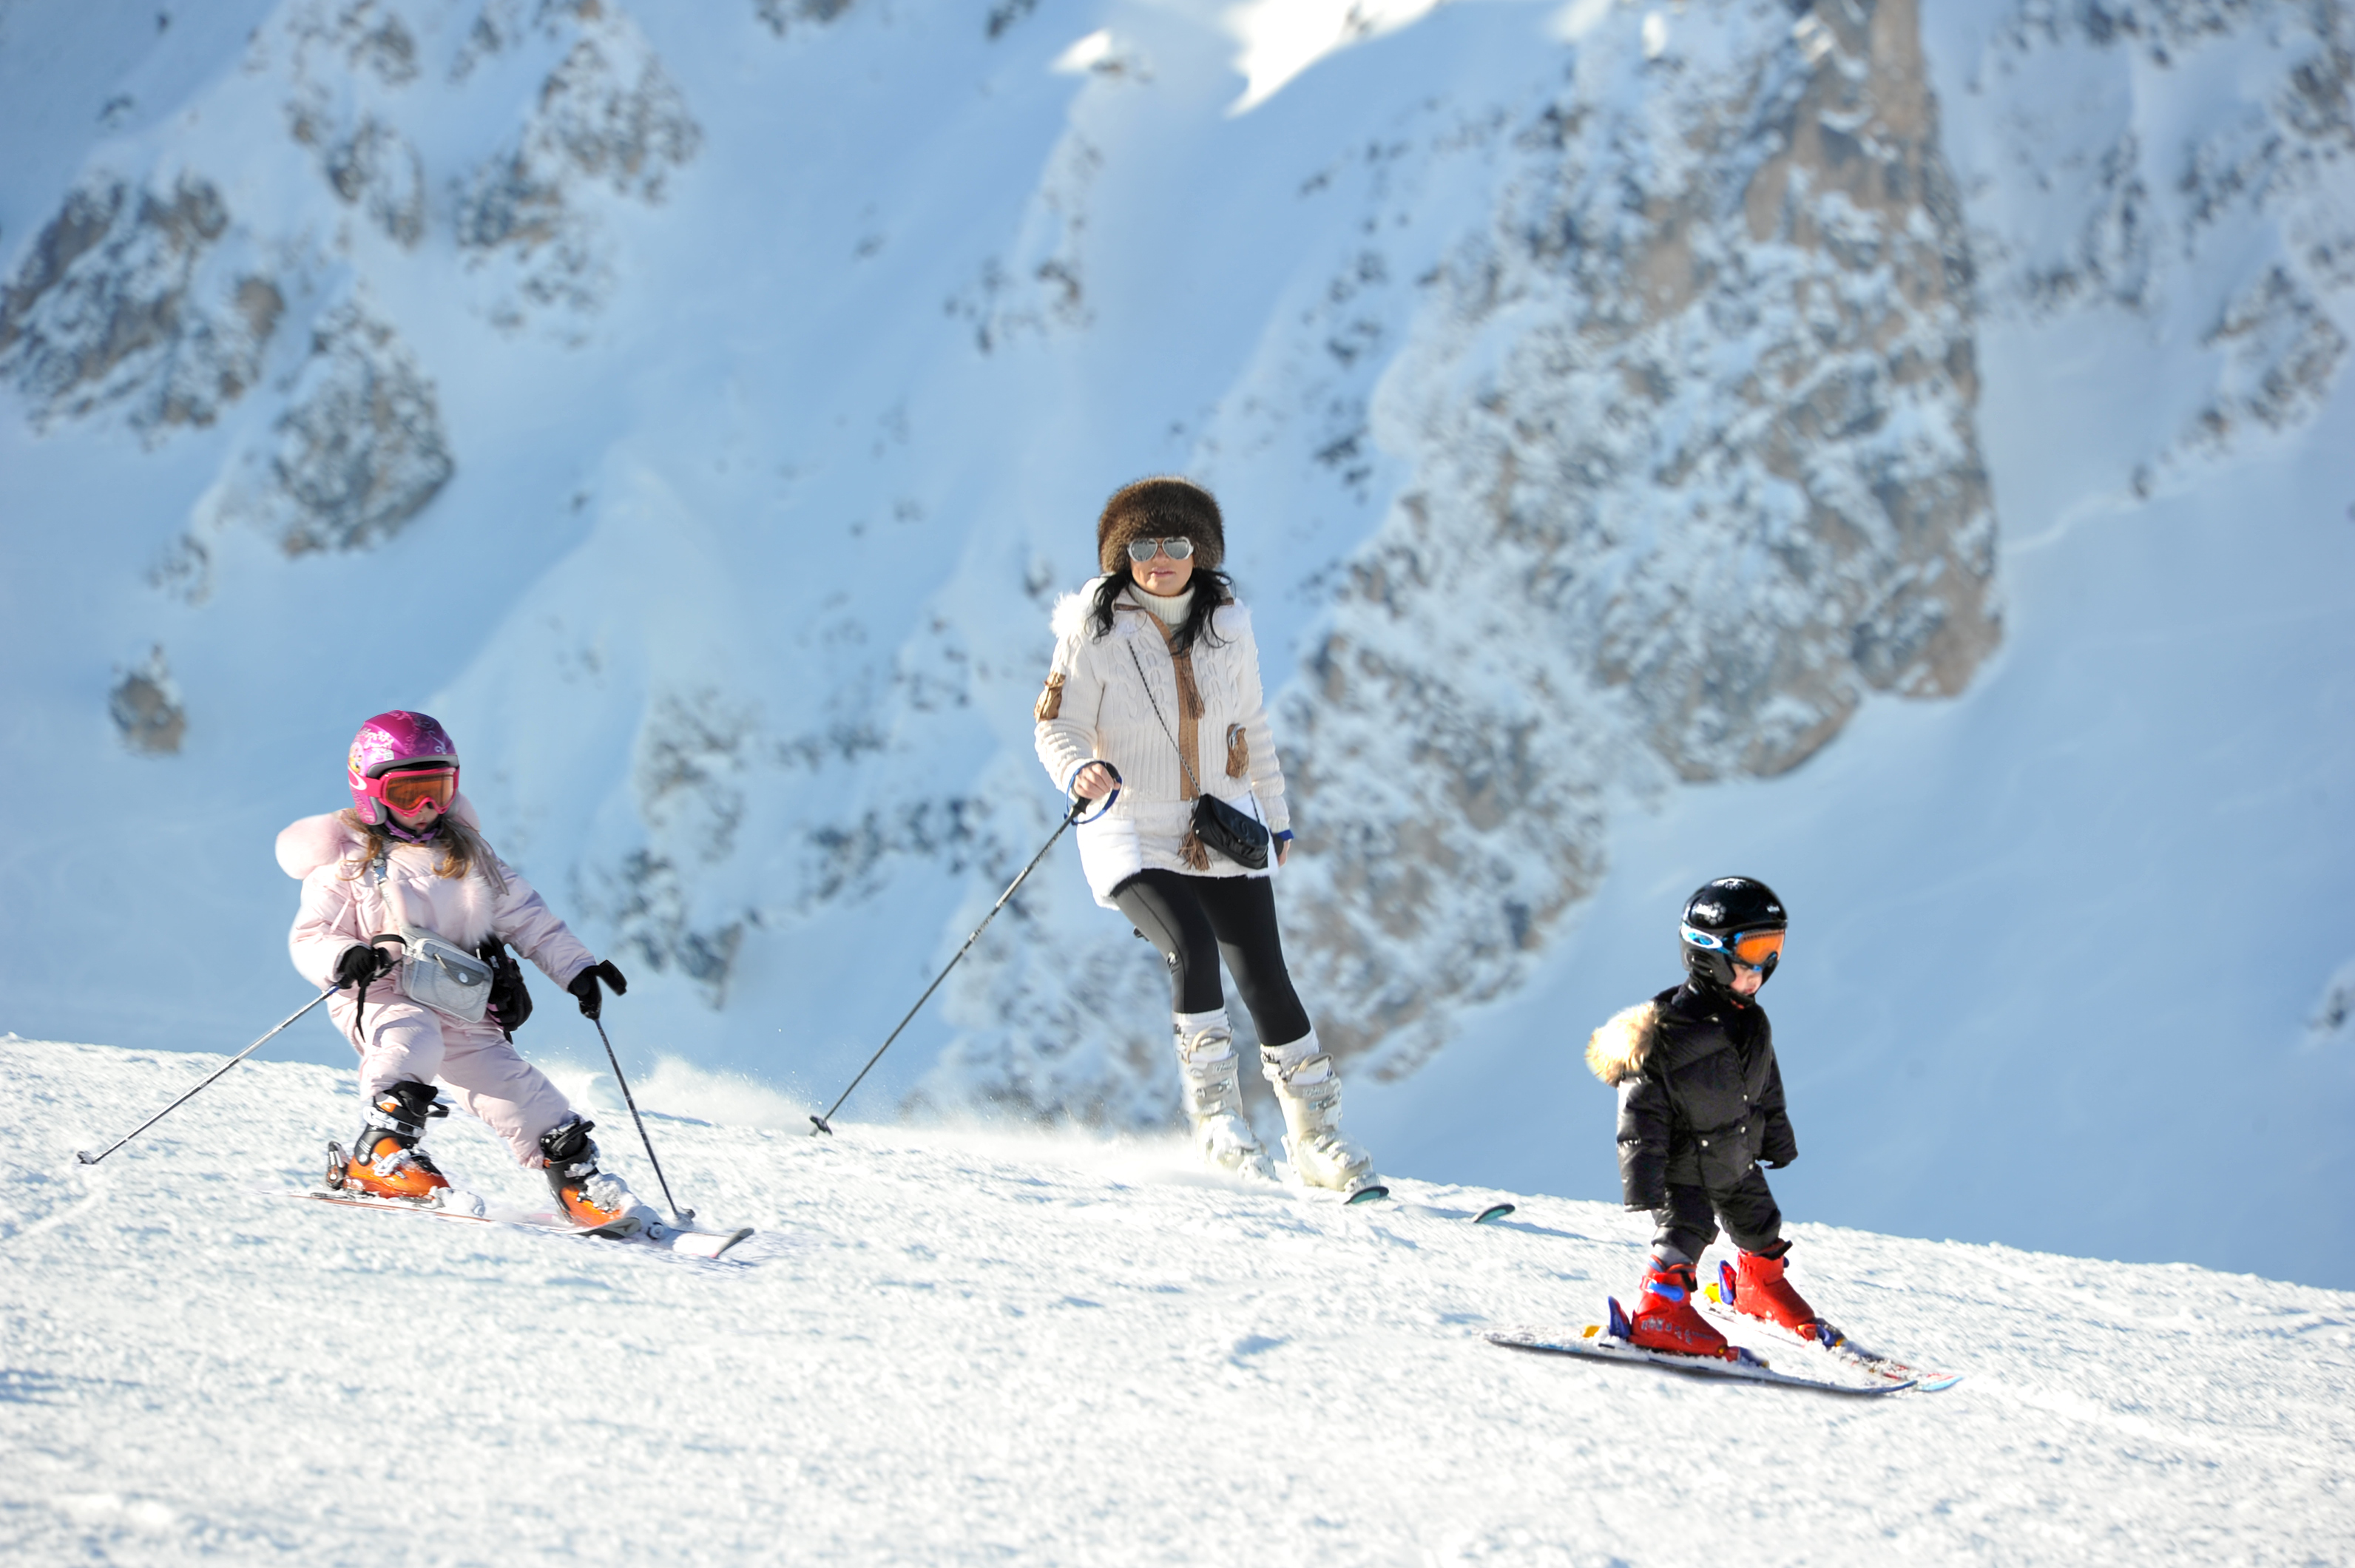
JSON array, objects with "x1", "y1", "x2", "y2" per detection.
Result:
[{"x1": 278, "y1": 796, "x2": 596, "y2": 1168}]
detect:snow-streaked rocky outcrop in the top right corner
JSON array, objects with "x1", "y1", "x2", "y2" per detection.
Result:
[{"x1": 1969, "y1": 0, "x2": 2355, "y2": 497}]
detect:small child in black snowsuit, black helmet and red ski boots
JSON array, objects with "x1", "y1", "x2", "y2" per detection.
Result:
[{"x1": 1587, "y1": 876, "x2": 1820, "y2": 1356}]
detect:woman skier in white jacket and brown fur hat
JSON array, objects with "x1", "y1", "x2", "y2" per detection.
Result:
[{"x1": 1036, "y1": 478, "x2": 1373, "y2": 1194}]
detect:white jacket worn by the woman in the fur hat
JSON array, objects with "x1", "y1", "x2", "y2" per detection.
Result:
[{"x1": 1036, "y1": 579, "x2": 1291, "y2": 909}]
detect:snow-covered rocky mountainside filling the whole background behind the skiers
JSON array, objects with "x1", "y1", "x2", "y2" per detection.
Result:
[{"x1": 0, "y1": 0, "x2": 2355, "y2": 1283}]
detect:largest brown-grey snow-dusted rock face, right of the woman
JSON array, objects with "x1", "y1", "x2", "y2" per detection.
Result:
[{"x1": 1288, "y1": 0, "x2": 1999, "y2": 1067}]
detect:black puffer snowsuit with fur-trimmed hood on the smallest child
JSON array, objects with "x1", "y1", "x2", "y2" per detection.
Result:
[{"x1": 1587, "y1": 981, "x2": 1800, "y2": 1257}]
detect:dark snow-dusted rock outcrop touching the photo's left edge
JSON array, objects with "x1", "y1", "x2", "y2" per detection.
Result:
[{"x1": 0, "y1": 175, "x2": 285, "y2": 440}]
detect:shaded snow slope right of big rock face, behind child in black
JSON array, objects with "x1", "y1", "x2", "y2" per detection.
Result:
[{"x1": 1352, "y1": 10, "x2": 2355, "y2": 1285}]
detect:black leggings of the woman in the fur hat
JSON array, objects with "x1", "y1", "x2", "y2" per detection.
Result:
[{"x1": 1112, "y1": 869, "x2": 1309, "y2": 1045}]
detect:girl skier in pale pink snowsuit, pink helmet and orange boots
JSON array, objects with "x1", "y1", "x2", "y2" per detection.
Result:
[{"x1": 278, "y1": 711, "x2": 643, "y2": 1226}]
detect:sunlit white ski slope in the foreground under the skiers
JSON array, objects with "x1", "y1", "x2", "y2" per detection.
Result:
[{"x1": 0, "y1": 1036, "x2": 2355, "y2": 1566}]
